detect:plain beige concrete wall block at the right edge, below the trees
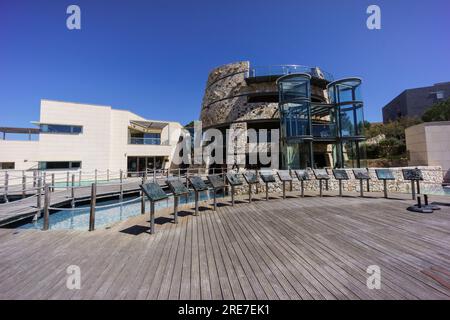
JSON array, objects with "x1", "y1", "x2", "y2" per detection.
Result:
[{"x1": 405, "y1": 121, "x2": 450, "y2": 170}]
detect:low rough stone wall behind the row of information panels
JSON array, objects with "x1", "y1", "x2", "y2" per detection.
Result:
[{"x1": 229, "y1": 167, "x2": 444, "y2": 194}]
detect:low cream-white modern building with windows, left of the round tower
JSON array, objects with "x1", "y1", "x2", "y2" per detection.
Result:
[{"x1": 0, "y1": 100, "x2": 182, "y2": 174}]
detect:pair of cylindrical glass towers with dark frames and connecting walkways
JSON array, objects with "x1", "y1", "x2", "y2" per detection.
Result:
[{"x1": 277, "y1": 73, "x2": 365, "y2": 169}]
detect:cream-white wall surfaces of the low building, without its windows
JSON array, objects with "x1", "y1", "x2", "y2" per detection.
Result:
[{"x1": 0, "y1": 100, "x2": 182, "y2": 175}]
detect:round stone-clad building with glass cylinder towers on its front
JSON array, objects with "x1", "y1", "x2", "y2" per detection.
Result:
[{"x1": 200, "y1": 61, "x2": 365, "y2": 169}]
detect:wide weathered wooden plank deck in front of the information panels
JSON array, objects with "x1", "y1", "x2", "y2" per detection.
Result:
[{"x1": 0, "y1": 195, "x2": 450, "y2": 299}]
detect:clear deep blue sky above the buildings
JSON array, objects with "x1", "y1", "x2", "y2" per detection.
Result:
[{"x1": 0, "y1": 0, "x2": 450, "y2": 126}]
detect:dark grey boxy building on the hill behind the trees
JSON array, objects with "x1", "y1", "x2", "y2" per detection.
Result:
[{"x1": 383, "y1": 82, "x2": 450, "y2": 123}]
